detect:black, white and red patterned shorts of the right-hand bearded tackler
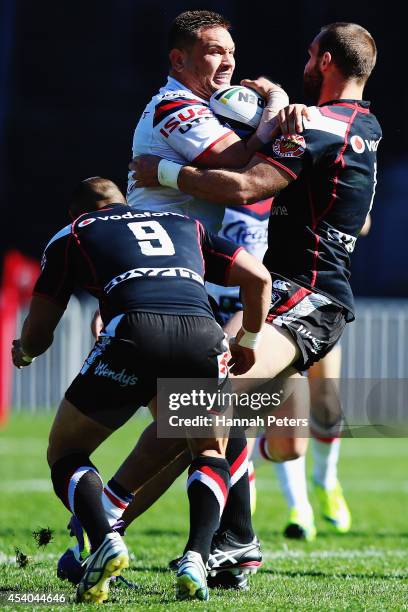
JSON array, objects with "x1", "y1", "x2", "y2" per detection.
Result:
[{"x1": 266, "y1": 274, "x2": 347, "y2": 372}]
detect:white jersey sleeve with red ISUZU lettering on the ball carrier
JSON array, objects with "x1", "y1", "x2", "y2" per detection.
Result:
[{"x1": 153, "y1": 96, "x2": 233, "y2": 162}]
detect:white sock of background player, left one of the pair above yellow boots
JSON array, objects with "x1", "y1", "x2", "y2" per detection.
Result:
[{"x1": 275, "y1": 457, "x2": 312, "y2": 514}]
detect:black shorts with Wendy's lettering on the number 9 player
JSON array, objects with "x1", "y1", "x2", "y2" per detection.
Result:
[{"x1": 65, "y1": 312, "x2": 228, "y2": 429}]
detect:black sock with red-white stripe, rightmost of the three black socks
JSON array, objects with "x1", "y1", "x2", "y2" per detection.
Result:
[{"x1": 219, "y1": 428, "x2": 255, "y2": 542}]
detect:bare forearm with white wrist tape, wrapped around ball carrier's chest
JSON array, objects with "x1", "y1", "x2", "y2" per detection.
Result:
[{"x1": 177, "y1": 166, "x2": 273, "y2": 206}]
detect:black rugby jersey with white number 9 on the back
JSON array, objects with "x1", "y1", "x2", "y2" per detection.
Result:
[{"x1": 34, "y1": 204, "x2": 241, "y2": 325}]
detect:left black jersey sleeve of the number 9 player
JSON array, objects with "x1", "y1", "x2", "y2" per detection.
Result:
[{"x1": 33, "y1": 225, "x2": 75, "y2": 309}]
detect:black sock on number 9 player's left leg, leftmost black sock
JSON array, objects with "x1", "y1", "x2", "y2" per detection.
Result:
[{"x1": 51, "y1": 453, "x2": 112, "y2": 550}]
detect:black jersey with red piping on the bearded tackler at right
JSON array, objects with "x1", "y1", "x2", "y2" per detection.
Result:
[{"x1": 258, "y1": 100, "x2": 382, "y2": 321}]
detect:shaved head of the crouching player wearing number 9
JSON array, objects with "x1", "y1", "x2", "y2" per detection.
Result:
[{"x1": 69, "y1": 176, "x2": 126, "y2": 218}]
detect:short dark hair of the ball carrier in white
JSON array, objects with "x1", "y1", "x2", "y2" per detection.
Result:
[{"x1": 168, "y1": 11, "x2": 231, "y2": 51}]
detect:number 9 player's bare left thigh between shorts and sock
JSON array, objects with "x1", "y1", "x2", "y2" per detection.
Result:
[{"x1": 47, "y1": 398, "x2": 112, "y2": 465}]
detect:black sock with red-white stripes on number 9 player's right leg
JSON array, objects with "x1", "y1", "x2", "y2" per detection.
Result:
[{"x1": 185, "y1": 455, "x2": 229, "y2": 563}]
